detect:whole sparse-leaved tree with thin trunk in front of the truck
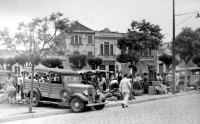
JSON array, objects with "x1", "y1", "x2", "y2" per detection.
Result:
[{"x1": 0, "y1": 12, "x2": 72, "y2": 113}]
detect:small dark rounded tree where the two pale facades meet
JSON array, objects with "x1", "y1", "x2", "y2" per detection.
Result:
[{"x1": 87, "y1": 58, "x2": 102, "y2": 70}]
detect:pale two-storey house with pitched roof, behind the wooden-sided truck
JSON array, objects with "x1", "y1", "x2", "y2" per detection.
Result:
[{"x1": 64, "y1": 22, "x2": 95, "y2": 69}]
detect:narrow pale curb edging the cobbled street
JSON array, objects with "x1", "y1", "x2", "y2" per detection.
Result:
[{"x1": 0, "y1": 91, "x2": 199, "y2": 123}]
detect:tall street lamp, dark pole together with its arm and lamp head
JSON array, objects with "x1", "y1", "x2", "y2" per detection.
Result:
[{"x1": 172, "y1": 0, "x2": 200, "y2": 94}]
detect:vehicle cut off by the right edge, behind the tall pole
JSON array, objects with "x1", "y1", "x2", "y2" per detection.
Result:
[{"x1": 176, "y1": 67, "x2": 200, "y2": 89}]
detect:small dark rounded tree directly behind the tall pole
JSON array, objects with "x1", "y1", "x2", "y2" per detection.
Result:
[{"x1": 158, "y1": 53, "x2": 179, "y2": 71}]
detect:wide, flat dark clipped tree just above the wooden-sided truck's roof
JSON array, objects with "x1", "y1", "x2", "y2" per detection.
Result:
[{"x1": 41, "y1": 58, "x2": 62, "y2": 68}]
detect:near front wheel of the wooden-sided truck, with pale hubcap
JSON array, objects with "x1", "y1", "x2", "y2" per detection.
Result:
[{"x1": 71, "y1": 97, "x2": 85, "y2": 113}]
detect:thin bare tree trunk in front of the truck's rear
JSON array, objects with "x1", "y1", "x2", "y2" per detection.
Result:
[{"x1": 28, "y1": 63, "x2": 34, "y2": 113}]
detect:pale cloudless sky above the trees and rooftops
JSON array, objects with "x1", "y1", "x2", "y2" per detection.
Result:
[{"x1": 0, "y1": 0, "x2": 200, "y2": 42}]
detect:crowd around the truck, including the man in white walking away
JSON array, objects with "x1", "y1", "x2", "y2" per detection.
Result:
[{"x1": 0, "y1": 70, "x2": 179, "y2": 107}]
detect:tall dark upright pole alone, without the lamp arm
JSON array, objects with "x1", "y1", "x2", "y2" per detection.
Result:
[{"x1": 172, "y1": 0, "x2": 176, "y2": 94}]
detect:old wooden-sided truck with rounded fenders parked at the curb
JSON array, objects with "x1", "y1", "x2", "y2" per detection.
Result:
[{"x1": 24, "y1": 67, "x2": 105, "y2": 112}]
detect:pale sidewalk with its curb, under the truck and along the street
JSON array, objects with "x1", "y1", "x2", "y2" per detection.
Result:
[{"x1": 0, "y1": 90, "x2": 199, "y2": 123}]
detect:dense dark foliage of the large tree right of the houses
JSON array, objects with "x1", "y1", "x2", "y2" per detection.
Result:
[{"x1": 117, "y1": 20, "x2": 163, "y2": 69}]
